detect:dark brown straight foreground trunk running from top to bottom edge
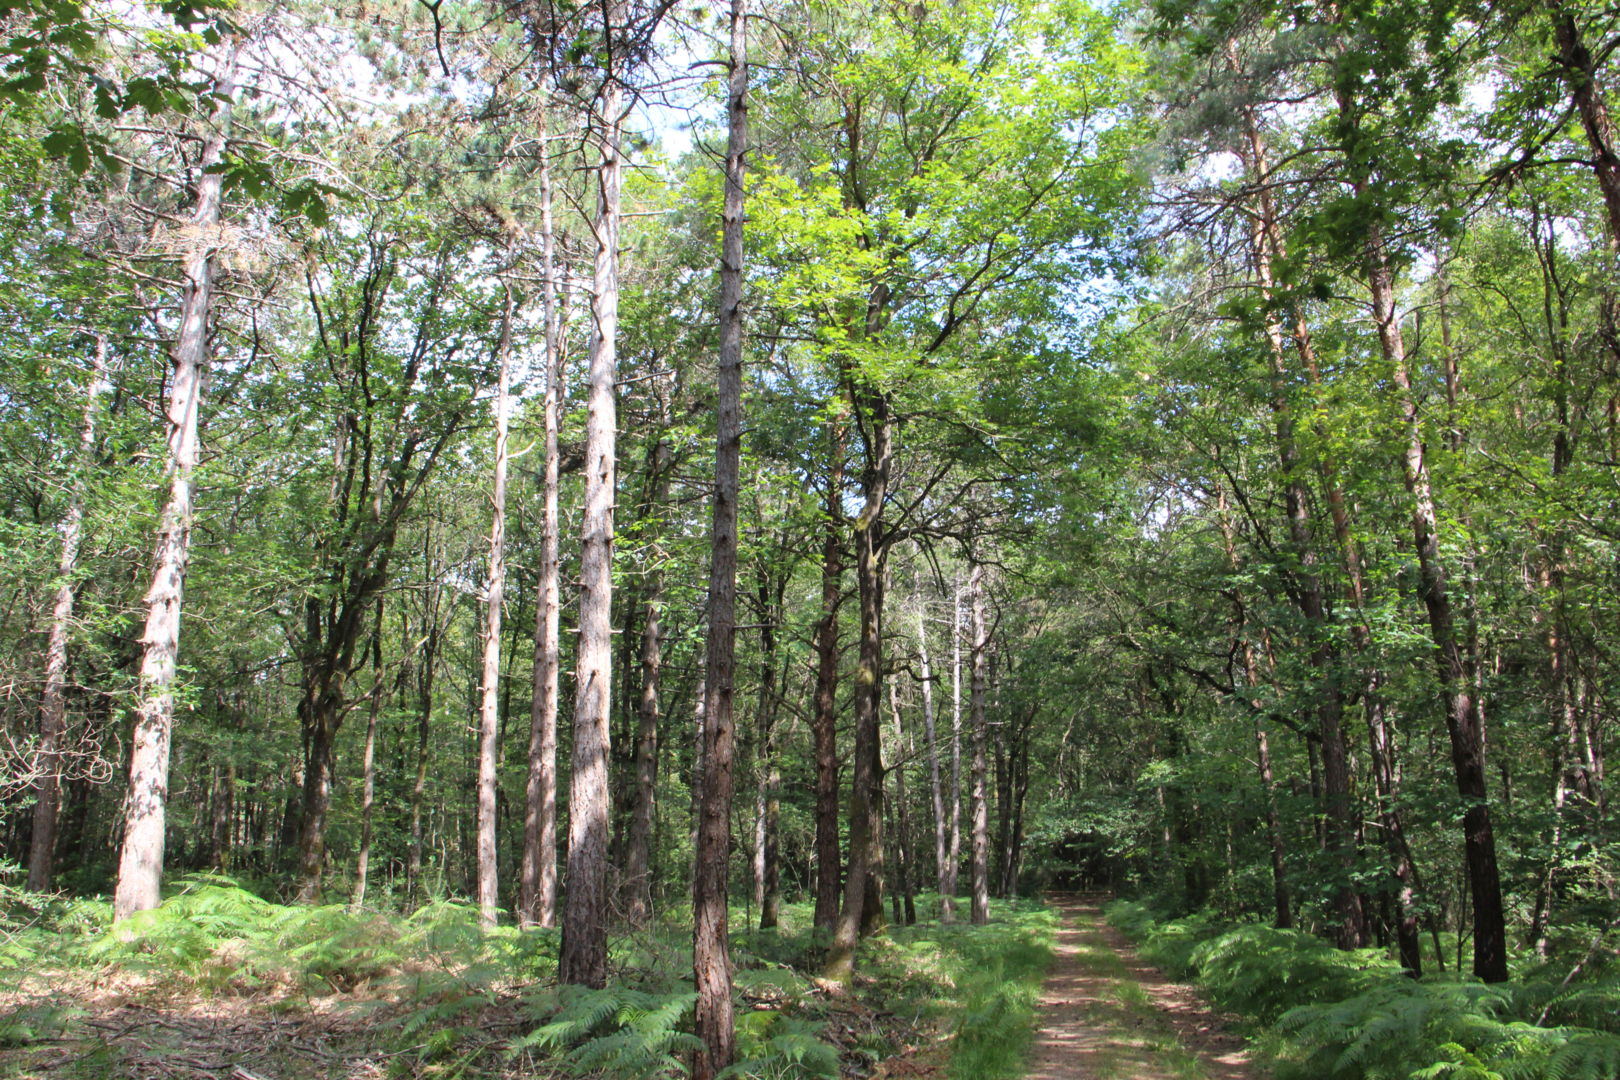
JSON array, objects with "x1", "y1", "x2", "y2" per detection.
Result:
[{"x1": 692, "y1": 0, "x2": 748, "y2": 1080}]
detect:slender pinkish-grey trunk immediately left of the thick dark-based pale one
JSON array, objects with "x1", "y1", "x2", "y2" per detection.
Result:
[{"x1": 518, "y1": 138, "x2": 562, "y2": 928}]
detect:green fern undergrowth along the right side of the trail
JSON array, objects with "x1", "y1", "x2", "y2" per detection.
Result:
[{"x1": 1108, "y1": 902, "x2": 1620, "y2": 1080}]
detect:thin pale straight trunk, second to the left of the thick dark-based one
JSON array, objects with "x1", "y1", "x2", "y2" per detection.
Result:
[{"x1": 478, "y1": 285, "x2": 517, "y2": 929}]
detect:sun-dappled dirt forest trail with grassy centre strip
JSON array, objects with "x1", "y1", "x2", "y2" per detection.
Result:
[{"x1": 1027, "y1": 895, "x2": 1257, "y2": 1080}]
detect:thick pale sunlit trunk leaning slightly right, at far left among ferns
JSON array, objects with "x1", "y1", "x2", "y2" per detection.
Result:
[{"x1": 113, "y1": 39, "x2": 241, "y2": 918}]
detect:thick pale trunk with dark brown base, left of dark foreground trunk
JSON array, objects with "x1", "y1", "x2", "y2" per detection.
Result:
[{"x1": 557, "y1": 74, "x2": 624, "y2": 988}]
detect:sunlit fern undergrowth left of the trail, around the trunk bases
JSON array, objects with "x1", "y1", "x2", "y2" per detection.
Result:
[{"x1": 0, "y1": 874, "x2": 1053, "y2": 1080}]
